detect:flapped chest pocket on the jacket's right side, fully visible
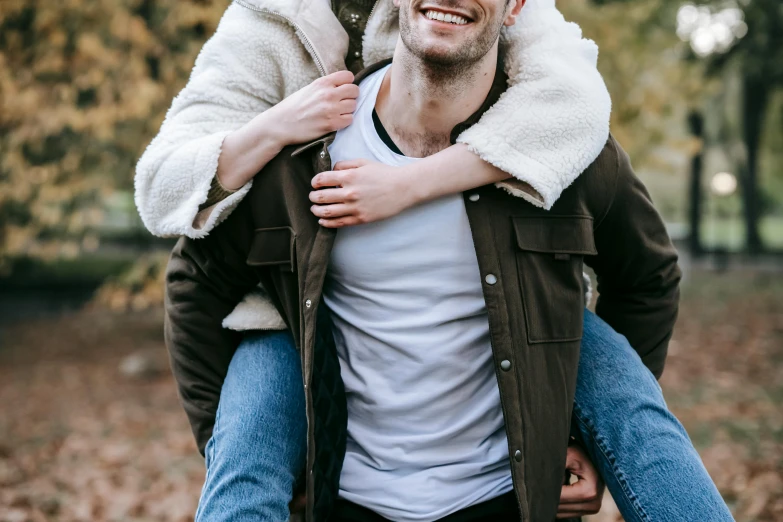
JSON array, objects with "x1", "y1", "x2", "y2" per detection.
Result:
[{"x1": 512, "y1": 216, "x2": 597, "y2": 344}]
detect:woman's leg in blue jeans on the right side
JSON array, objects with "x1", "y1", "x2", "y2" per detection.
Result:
[{"x1": 574, "y1": 310, "x2": 733, "y2": 522}]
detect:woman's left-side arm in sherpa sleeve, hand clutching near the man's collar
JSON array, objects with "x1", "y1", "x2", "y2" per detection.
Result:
[{"x1": 135, "y1": 4, "x2": 358, "y2": 238}]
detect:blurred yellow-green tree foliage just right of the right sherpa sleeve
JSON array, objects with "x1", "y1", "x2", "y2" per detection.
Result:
[{"x1": 557, "y1": 0, "x2": 712, "y2": 168}]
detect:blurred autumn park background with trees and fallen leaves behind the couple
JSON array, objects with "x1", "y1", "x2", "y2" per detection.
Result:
[{"x1": 0, "y1": 0, "x2": 783, "y2": 522}]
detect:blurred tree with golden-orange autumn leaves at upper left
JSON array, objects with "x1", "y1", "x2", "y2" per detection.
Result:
[{"x1": 0, "y1": 0, "x2": 229, "y2": 275}]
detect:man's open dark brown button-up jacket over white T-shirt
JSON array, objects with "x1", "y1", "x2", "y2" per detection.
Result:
[{"x1": 166, "y1": 62, "x2": 680, "y2": 522}]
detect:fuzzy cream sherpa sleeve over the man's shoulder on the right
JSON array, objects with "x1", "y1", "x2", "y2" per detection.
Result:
[{"x1": 457, "y1": 0, "x2": 611, "y2": 210}]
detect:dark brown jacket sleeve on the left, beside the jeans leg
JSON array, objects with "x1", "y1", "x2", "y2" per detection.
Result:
[{"x1": 165, "y1": 196, "x2": 258, "y2": 454}]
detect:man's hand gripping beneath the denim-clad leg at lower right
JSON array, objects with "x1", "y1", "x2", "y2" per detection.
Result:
[{"x1": 557, "y1": 446, "x2": 604, "y2": 518}]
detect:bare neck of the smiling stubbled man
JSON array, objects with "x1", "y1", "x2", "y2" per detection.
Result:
[{"x1": 375, "y1": 41, "x2": 498, "y2": 158}]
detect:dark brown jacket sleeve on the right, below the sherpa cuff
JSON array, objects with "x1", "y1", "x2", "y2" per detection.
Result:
[{"x1": 585, "y1": 139, "x2": 681, "y2": 378}]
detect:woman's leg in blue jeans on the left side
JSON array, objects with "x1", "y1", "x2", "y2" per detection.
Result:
[{"x1": 196, "y1": 331, "x2": 307, "y2": 522}]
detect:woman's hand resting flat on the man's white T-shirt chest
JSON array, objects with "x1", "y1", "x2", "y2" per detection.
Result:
[{"x1": 310, "y1": 159, "x2": 418, "y2": 228}]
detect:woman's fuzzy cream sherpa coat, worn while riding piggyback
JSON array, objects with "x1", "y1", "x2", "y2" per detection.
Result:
[{"x1": 135, "y1": 0, "x2": 611, "y2": 330}]
